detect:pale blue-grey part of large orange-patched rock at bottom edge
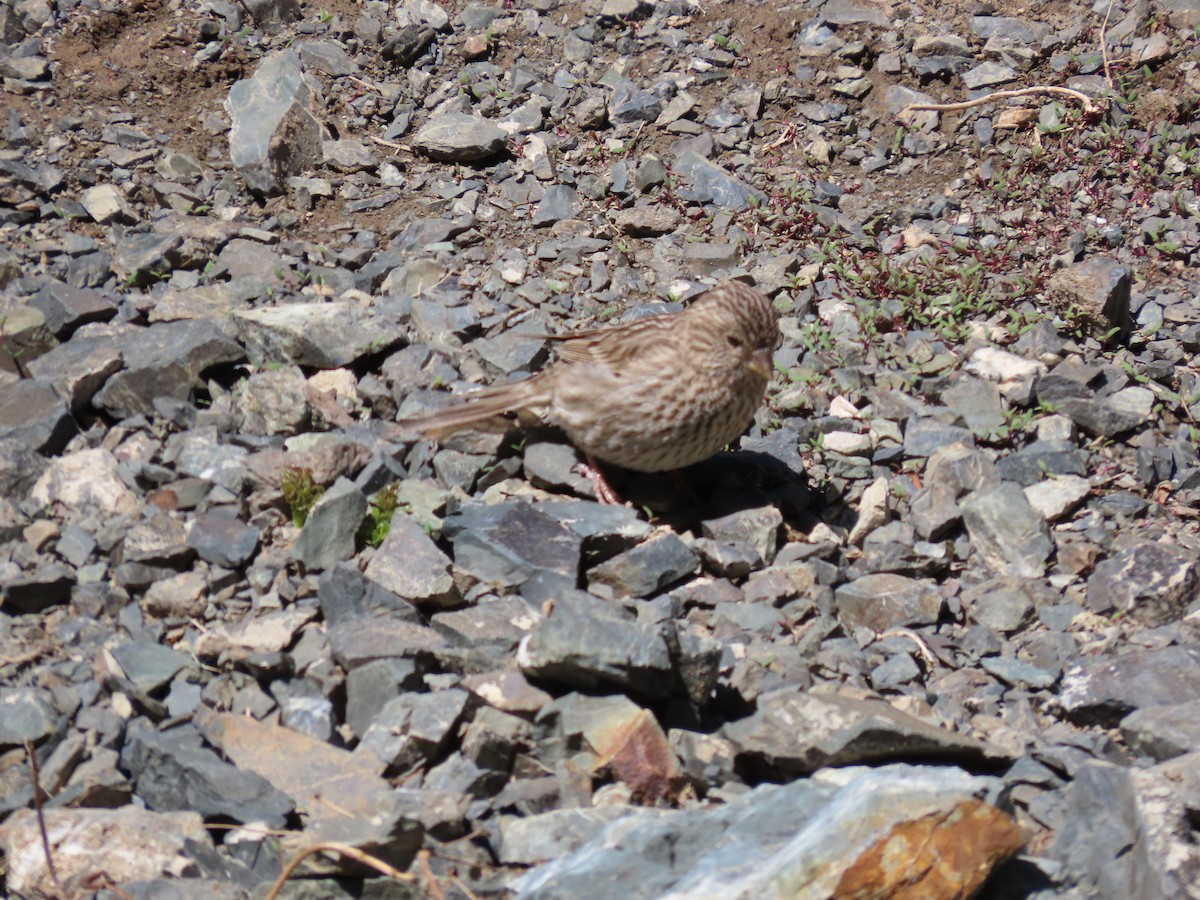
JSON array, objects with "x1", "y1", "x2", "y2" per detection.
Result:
[{"x1": 514, "y1": 766, "x2": 1022, "y2": 900}]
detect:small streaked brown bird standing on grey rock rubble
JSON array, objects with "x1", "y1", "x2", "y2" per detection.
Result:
[{"x1": 397, "y1": 281, "x2": 780, "y2": 503}]
